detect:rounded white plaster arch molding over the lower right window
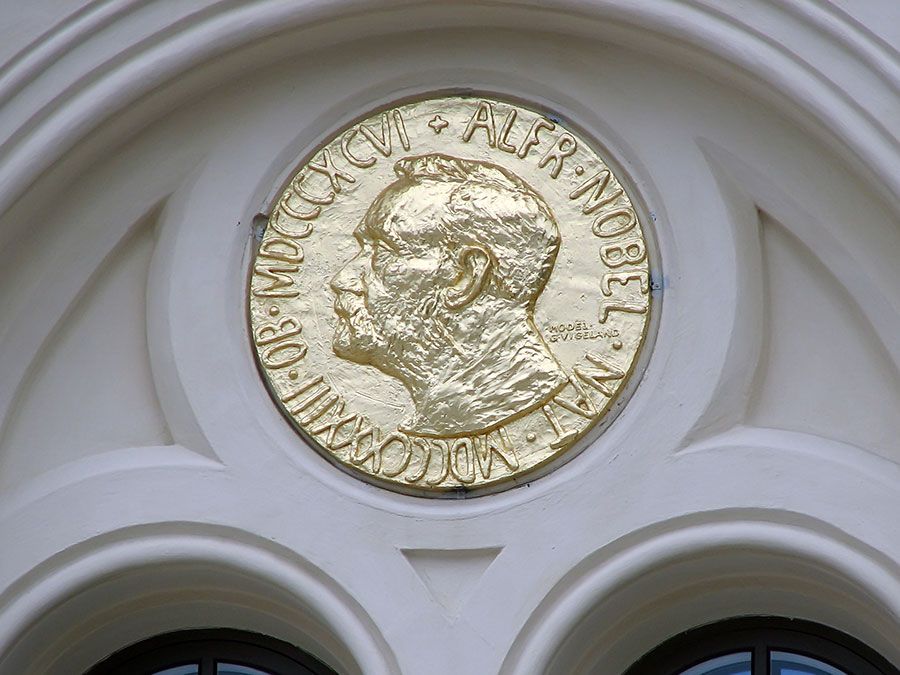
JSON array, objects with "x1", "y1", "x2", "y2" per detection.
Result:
[{"x1": 500, "y1": 509, "x2": 900, "y2": 675}]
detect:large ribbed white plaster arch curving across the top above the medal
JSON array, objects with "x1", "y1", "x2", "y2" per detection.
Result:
[{"x1": 0, "y1": 0, "x2": 900, "y2": 222}]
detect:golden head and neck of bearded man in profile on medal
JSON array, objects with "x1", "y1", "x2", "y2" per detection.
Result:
[{"x1": 331, "y1": 154, "x2": 567, "y2": 437}]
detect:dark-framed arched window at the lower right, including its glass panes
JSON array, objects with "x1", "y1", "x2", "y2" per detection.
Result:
[{"x1": 626, "y1": 617, "x2": 900, "y2": 675}]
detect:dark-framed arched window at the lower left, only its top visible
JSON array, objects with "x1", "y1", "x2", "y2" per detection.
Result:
[{"x1": 86, "y1": 629, "x2": 336, "y2": 675}]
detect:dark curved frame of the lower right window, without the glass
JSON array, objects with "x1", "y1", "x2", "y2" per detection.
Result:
[{"x1": 625, "y1": 616, "x2": 900, "y2": 675}]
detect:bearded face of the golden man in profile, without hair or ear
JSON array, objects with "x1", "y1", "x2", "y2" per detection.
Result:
[{"x1": 331, "y1": 186, "x2": 452, "y2": 375}]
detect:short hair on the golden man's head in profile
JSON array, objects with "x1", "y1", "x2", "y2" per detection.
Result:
[{"x1": 373, "y1": 154, "x2": 560, "y2": 305}]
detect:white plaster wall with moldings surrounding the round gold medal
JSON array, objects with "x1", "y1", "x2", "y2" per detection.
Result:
[{"x1": 0, "y1": 0, "x2": 900, "y2": 675}]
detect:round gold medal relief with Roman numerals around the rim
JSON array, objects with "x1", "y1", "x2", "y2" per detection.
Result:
[{"x1": 249, "y1": 97, "x2": 651, "y2": 496}]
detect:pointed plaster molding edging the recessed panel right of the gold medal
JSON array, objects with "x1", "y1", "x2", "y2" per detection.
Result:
[{"x1": 687, "y1": 138, "x2": 900, "y2": 444}]
